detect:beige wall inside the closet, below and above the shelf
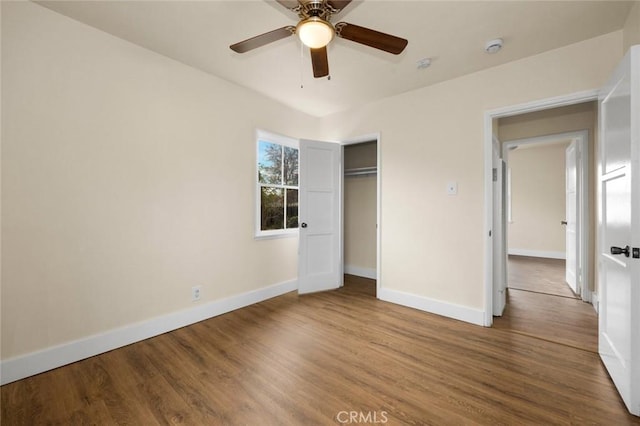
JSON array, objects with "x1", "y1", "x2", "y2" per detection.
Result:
[{"x1": 344, "y1": 142, "x2": 377, "y2": 276}]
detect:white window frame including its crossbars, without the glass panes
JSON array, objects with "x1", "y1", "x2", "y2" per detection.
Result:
[{"x1": 253, "y1": 129, "x2": 300, "y2": 239}]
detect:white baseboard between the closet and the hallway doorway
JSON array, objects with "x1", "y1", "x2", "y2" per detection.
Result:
[{"x1": 378, "y1": 288, "x2": 484, "y2": 326}]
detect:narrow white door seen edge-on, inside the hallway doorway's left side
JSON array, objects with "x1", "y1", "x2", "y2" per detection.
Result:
[{"x1": 492, "y1": 139, "x2": 507, "y2": 317}]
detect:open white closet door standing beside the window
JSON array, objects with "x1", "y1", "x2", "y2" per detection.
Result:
[{"x1": 298, "y1": 140, "x2": 342, "y2": 294}]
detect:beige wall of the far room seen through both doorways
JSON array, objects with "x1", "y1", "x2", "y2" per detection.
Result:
[{"x1": 508, "y1": 142, "x2": 568, "y2": 257}]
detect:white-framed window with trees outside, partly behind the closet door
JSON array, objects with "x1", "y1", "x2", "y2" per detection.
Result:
[{"x1": 256, "y1": 131, "x2": 298, "y2": 237}]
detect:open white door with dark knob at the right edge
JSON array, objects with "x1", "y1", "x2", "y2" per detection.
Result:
[{"x1": 598, "y1": 46, "x2": 640, "y2": 415}]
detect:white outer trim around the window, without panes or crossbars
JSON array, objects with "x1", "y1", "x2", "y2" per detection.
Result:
[{"x1": 253, "y1": 129, "x2": 300, "y2": 240}]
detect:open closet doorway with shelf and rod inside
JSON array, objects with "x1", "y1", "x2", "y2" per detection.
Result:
[{"x1": 343, "y1": 136, "x2": 379, "y2": 296}]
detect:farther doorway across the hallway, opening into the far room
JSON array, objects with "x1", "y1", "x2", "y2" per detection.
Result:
[{"x1": 502, "y1": 131, "x2": 593, "y2": 301}]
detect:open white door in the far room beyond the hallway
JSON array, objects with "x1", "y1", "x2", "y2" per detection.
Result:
[{"x1": 564, "y1": 140, "x2": 580, "y2": 295}]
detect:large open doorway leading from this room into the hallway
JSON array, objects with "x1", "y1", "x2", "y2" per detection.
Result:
[{"x1": 493, "y1": 102, "x2": 597, "y2": 352}]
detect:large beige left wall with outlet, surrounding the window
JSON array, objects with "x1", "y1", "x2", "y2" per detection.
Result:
[{"x1": 2, "y1": 2, "x2": 317, "y2": 359}]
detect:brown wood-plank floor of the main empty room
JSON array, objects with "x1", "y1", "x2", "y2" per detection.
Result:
[{"x1": 1, "y1": 279, "x2": 640, "y2": 425}]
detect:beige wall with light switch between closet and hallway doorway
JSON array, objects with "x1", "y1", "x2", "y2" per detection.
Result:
[{"x1": 323, "y1": 31, "x2": 622, "y2": 309}]
